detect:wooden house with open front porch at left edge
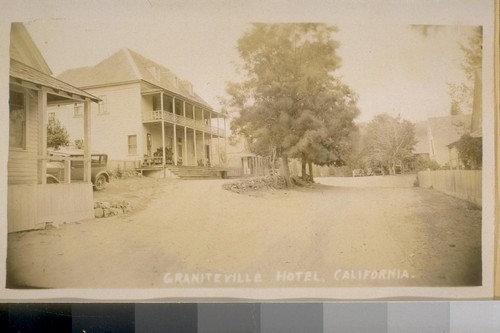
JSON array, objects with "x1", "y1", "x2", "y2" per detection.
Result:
[{"x1": 7, "y1": 23, "x2": 99, "y2": 232}]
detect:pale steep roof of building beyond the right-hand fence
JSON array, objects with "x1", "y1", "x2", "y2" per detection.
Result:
[{"x1": 428, "y1": 114, "x2": 472, "y2": 149}]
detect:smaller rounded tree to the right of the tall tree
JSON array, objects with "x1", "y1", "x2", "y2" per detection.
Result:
[{"x1": 364, "y1": 113, "x2": 417, "y2": 173}]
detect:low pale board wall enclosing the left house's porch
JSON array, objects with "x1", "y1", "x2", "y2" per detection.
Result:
[{"x1": 7, "y1": 183, "x2": 94, "y2": 232}]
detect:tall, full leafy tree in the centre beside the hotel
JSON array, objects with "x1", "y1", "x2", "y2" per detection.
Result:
[{"x1": 226, "y1": 23, "x2": 358, "y2": 183}]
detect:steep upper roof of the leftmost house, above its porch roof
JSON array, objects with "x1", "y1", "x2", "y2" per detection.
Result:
[{"x1": 10, "y1": 22, "x2": 52, "y2": 75}]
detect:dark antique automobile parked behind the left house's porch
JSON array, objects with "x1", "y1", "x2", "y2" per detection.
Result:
[{"x1": 46, "y1": 150, "x2": 109, "y2": 191}]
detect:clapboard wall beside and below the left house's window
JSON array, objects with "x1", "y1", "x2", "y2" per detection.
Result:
[{"x1": 7, "y1": 90, "x2": 38, "y2": 184}]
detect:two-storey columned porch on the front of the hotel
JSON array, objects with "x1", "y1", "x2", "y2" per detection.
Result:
[{"x1": 141, "y1": 90, "x2": 227, "y2": 168}]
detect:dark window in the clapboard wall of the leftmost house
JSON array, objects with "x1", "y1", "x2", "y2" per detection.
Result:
[{"x1": 9, "y1": 91, "x2": 26, "y2": 149}]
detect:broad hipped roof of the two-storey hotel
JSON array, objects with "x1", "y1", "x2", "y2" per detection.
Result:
[{"x1": 58, "y1": 48, "x2": 211, "y2": 109}]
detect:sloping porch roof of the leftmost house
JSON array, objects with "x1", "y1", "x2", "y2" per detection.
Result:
[{"x1": 9, "y1": 59, "x2": 99, "y2": 102}]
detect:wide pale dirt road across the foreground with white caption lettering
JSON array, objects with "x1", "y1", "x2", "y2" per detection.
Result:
[{"x1": 7, "y1": 176, "x2": 481, "y2": 288}]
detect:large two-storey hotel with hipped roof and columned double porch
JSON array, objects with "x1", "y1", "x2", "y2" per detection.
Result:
[{"x1": 50, "y1": 48, "x2": 226, "y2": 175}]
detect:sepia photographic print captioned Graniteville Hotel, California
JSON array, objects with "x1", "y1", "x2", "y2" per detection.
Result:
[{"x1": 0, "y1": 0, "x2": 493, "y2": 295}]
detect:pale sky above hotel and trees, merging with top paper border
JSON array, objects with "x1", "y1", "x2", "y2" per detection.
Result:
[{"x1": 1, "y1": 0, "x2": 490, "y2": 121}]
